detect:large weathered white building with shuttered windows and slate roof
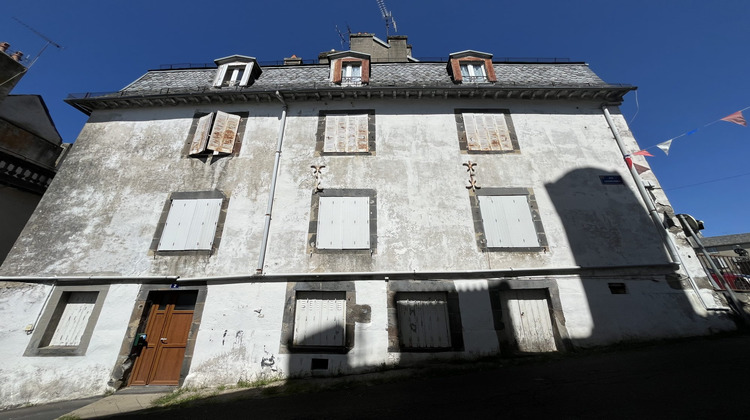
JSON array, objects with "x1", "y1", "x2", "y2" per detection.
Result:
[{"x1": 0, "y1": 34, "x2": 735, "y2": 406}]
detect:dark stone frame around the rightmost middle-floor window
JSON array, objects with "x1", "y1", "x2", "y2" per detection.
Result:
[{"x1": 469, "y1": 188, "x2": 549, "y2": 252}]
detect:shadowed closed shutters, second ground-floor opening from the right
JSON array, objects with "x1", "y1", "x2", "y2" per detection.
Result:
[{"x1": 396, "y1": 293, "x2": 451, "y2": 349}]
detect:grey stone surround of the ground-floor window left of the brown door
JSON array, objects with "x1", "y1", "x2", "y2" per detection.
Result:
[{"x1": 23, "y1": 285, "x2": 109, "y2": 357}]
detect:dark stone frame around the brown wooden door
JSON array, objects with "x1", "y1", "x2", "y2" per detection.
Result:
[{"x1": 109, "y1": 283, "x2": 207, "y2": 389}]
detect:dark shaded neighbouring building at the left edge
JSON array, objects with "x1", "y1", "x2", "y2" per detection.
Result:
[{"x1": 0, "y1": 42, "x2": 69, "y2": 263}]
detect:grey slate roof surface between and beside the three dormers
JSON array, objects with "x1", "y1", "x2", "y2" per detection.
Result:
[{"x1": 123, "y1": 63, "x2": 608, "y2": 92}]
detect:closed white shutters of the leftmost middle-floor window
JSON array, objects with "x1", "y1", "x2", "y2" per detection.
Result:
[{"x1": 157, "y1": 198, "x2": 223, "y2": 251}]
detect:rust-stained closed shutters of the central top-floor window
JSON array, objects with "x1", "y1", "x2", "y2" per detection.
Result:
[{"x1": 323, "y1": 114, "x2": 369, "y2": 153}]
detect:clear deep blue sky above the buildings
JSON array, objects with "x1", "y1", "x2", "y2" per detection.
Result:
[{"x1": 0, "y1": 0, "x2": 750, "y2": 236}]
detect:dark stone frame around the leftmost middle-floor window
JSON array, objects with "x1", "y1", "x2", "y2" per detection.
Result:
[{"x1": 149, "y1": 190, "x2": 229, "y2": 255}]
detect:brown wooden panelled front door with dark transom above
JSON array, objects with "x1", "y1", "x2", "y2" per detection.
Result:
[{"x1": 129, "y1": 291, "x2": 198, "y2": 385}]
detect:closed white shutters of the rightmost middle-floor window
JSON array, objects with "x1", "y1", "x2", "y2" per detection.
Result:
[{"x1": 477, "y1": 195, "x2": 540, "y2": 248}]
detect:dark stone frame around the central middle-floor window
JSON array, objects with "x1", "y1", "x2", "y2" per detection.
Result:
[{"x1": 307, "y1": 189, "x2": 377, "y2": 255}]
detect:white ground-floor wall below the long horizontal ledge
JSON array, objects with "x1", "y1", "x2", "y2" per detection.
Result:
[{"x1": 0, "y1": 275, "x2": 734, "y2": 408}]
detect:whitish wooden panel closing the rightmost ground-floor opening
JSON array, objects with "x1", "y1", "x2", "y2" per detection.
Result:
[{"x1": 501, "y1": 289, "x2": 557, "y2": 353}]
